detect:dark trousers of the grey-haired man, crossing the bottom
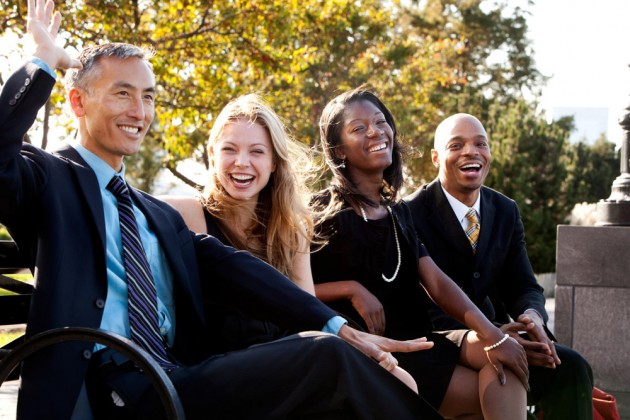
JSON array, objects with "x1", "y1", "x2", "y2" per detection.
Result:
[{"x1": 86, "y1": 333, "x2": 441, "y2": 420}]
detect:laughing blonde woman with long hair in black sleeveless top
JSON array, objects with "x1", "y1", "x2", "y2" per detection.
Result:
[{"x1": 162, "y1": 94, "x2": 315, "y2": 351}]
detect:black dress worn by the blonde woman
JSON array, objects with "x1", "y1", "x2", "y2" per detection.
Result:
[{"x1": 203, "y1": 208, "x2": 293, "y2": 354}]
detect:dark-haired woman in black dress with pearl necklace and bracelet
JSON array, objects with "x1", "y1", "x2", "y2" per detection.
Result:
[{"x1": 311, "y1": 87, "x2": 527, "y2": 419}]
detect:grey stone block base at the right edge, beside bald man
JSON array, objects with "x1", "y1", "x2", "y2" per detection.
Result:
[{"x1": 555, "y1": 225, "x2": 630, "y2": 418}]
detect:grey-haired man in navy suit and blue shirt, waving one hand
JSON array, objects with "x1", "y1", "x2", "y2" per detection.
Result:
[{"x1": 0, "y1": 0, "x2": 438, "y2": 419}]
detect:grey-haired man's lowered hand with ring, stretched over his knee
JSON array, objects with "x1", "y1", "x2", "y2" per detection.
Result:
[{"x1": 337, "y1": 325, "x2": 433, "y2": 370}]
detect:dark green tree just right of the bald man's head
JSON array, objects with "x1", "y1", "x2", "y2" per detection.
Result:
[{"x1": 486, "y1": 100, "x2": 573, "y2": 273}]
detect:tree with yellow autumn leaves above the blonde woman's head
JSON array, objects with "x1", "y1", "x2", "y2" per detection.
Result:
[{"x1": 0, "y1": 0, "x2": 436, "y2": 187}]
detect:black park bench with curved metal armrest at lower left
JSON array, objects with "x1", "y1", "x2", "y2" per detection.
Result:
[{"x1": 0, "y1": 240, "x2": 185, "y2": 419}]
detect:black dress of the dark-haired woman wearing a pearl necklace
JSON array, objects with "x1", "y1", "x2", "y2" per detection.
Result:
[{"x1": 311, "y1": 192, "x2": 459, "y2": 408}]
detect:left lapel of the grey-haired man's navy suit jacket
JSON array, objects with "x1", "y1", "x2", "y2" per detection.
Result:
[{"x1": 55, "y1": 146, "x2": 105, "y2": 250}]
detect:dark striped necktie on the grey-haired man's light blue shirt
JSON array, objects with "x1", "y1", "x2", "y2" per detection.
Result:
[{"x1": 107, "y1": 176, "x2": 175, "y2": 370}]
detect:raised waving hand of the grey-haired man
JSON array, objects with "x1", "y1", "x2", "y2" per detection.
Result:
[{"x1": 26, "y1": 0, "x2": 82, "y2": 69}]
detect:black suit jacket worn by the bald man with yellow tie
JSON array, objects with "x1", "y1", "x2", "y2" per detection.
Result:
[{"x1": 405, "y1": 179, "x2": 548, "y2": 329}]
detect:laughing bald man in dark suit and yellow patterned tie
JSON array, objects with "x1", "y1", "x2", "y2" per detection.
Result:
[{"x1": 405, "y1": 114, "x2": 593, "y2": 419}]
